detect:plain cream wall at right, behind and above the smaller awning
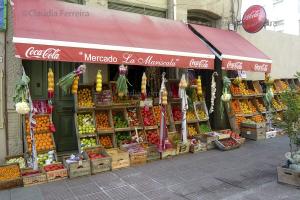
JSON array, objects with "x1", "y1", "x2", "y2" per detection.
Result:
[{"x1": 238, "y1": 28, "x2": 300, "y2": 79}]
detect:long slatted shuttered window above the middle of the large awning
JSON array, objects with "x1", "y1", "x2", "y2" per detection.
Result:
[{"x1": 108, "y1": 1, "x2": 167, "y2": 18}]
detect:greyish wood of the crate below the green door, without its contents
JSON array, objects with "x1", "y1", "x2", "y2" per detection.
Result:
[{"x1": 63, "y1": 153, "x2": 91, "y2": 178}]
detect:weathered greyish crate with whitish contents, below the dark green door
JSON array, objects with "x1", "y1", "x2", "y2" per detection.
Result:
[{"x1": 63, "y1": 152, "x2": 91, "y2": 178}]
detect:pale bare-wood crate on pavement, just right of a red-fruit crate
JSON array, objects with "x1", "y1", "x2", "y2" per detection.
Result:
[{"x1": 107, "y1": 148, "x2": 130, "y2": 170}]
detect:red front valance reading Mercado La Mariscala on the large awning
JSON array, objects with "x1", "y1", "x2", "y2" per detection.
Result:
[{"x1": 14, "y1": 43, "x2": 214, "y2": 70}]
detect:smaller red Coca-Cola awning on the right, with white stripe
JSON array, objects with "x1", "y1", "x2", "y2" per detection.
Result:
[{"x1": 190, "y1": 24, "x2": 272, "y2": 72}]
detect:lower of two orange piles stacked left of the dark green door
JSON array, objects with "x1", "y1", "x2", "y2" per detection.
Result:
[{"x1": 26, "y1": 133, "x2": 54, "y2": 152}]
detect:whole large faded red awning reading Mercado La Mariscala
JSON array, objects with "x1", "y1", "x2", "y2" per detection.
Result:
[{"x1": 13, "y1": 0, "x2": 214, "y2": 69}]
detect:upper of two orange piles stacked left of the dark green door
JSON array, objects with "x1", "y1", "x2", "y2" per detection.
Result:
[{"x1": 25, "y1": 115, "x2": 50, "y2": 133}]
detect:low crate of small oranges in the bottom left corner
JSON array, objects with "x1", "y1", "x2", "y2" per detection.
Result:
[{"x1": 0, "y1": 163, "x2": 23, "y2": 190}]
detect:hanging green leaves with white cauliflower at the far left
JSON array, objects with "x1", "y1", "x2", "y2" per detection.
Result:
[{"x1": 13, "y1": 72, "x2": 30, "y2": 115}]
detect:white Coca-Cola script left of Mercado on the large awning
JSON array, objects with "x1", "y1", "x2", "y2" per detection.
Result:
[{"x1": 25, "y1": 47, "x2": 61, "y2": 60}]
